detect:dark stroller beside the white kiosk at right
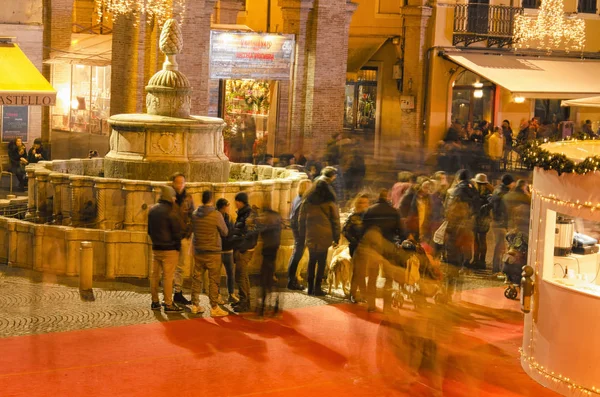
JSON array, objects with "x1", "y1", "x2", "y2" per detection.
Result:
[{"x1": 502, "y1": 230, "x2": 528, "y2": 300}]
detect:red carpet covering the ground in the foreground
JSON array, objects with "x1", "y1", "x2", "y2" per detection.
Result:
[{"x1": 0, "y1": 288, "x2": 556, "y2": 397}]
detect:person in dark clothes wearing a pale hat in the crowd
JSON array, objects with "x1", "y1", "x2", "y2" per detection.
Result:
[{"x1": 471, "y1": 174, "x2": 493, "y2": 269}]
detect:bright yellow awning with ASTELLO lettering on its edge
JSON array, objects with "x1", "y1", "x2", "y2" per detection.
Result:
[{"x1": 0, "y1": 43, "x2": 56, "y2": 106}]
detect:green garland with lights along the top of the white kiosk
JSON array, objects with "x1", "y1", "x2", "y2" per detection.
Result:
[{"x1": 521, "y1": 141, "x2": 600, "y2": 175}]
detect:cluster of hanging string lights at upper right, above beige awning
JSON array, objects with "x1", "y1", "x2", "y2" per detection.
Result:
[{"x1": 513, "y1": 0, "x2": 585, "y2": 52}]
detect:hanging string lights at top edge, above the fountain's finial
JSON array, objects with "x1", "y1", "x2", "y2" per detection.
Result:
[{"x1": 95, "y1": 0, "x2": 186, "y2": 27}]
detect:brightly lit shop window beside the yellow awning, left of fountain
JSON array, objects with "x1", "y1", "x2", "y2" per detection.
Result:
[{"x1": 51, "y1": 64, "x2": 110, "y2": 134}]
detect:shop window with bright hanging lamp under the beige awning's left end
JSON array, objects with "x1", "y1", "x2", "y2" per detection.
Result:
[{"x1": 452, "y1": 71, "x2": 496, "y2": 126}]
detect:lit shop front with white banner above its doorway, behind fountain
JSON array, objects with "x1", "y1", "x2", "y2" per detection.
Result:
[{"x1": 210, "y1": 30, "x2": 295, "y2": 162}]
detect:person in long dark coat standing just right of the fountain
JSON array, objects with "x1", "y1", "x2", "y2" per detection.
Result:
[{"x1": 298, "y1": 180, "x2": 340, "y2": 296}]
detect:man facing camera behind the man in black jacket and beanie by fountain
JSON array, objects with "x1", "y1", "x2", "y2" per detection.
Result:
[{"x1": 171, "y1": 172, "x2": 194, "y2": 305}]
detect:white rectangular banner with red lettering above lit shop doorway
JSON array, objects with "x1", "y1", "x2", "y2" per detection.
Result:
[{"x1": 210, "y1": 30, "x2": 295, "y2": 81}]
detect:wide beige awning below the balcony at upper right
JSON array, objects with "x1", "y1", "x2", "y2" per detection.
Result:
[{"x1": 445, "y1": 51, "x2": 600, "y2": 99}]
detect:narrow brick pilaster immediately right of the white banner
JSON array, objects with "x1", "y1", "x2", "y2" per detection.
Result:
[{"x1": 279, "y1": 0, "x2": 314, "y2": 153}]
